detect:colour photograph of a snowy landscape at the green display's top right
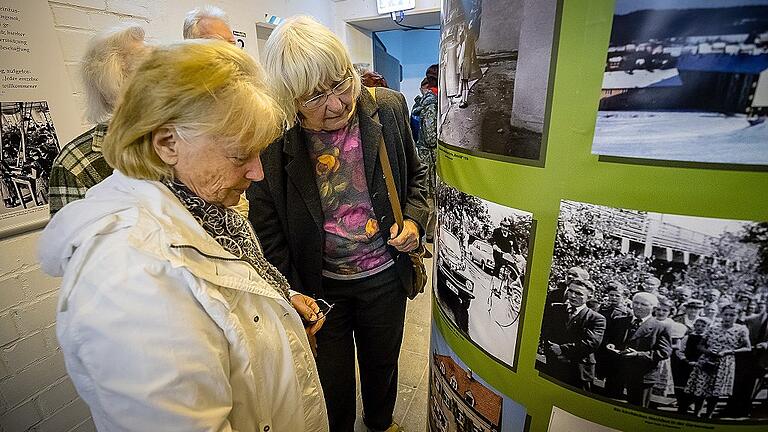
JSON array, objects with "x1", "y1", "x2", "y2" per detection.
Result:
[{"x1": 592, "y1": 0, "x2": 768, "y2": 165}]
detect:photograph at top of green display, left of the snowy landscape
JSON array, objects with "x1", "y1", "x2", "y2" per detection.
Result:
[{"x1": 438, "y1": 0, "x2": 559, "y2": 162}]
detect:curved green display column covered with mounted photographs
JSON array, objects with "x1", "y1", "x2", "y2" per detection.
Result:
[{"x1": 430, "y1": 0, "x2": 768, "y2": 432}]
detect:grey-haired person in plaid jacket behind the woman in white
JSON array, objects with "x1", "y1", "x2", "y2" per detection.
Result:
[{"x1": 48, "y1": 25, "x2": 149, "y2": 216}]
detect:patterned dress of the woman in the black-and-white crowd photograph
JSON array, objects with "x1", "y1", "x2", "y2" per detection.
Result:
[{"x1": 685, "y1": 324, "x2": 749, "y2": 397}]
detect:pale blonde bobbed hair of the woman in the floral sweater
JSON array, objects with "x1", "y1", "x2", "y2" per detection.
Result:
[{"x1": 264, "y1": 16, "x2": 361, "y2": 124}]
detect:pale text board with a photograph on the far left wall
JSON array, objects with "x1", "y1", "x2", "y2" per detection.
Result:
[{"x1": 0, "y1": 0, "x2": 81, "y2": 237}]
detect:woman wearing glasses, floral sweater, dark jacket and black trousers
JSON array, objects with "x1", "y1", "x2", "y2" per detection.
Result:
[{"x1": 247, "y1": 17, "x2": 429, "y2": 432}]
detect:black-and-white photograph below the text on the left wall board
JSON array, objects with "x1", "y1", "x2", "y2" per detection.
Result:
[{"x1": 0, "y1": 101, "x2": 59, "y2": 218}]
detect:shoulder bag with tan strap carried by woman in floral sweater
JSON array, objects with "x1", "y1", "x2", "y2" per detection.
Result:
[{"x1": 368, "y1": 87, "x2": 432, "y2": 300}]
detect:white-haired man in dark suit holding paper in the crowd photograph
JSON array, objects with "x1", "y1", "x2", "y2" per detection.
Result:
[{"x1": 604, "y1": 292, "x2": 672, "y2": 407}]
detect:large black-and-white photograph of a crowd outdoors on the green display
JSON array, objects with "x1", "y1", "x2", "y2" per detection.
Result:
[{"x1": 536, "y1": 200, "x2": 768, "y2": 423}]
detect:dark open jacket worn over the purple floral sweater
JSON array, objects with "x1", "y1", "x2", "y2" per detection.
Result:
[{"x1": 246, "y1": 87, "x2": 429, "y2": 297}]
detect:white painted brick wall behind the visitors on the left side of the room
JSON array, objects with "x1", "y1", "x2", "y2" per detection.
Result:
[{"x1": 0, "y1": 0, "x2": 337, "y2": 432}]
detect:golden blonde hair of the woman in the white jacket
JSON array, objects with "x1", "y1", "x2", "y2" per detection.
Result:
[{"x1": 102, "y1": 39, "x2": 285, "y2": 180}]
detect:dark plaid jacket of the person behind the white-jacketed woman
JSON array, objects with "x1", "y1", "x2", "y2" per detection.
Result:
[{"x1": 48, "y1": 123, "x2": 112, "y2": 216}]
